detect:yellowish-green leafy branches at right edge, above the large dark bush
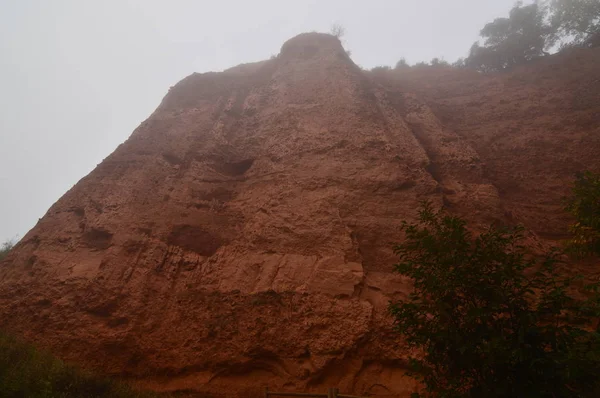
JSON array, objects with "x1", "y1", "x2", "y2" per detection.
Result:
[{"x1": 566, "y1": 171, "x2": 600, "y2": 256}]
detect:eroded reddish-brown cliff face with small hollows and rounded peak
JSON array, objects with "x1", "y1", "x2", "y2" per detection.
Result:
[{"x1": 0, "y1": 33, "x2": 600, "y2": 396}]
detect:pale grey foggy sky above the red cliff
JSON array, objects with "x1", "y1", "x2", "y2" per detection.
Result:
[{"x1": 0, "y1": 0, "x2": 514, "y2": 242}]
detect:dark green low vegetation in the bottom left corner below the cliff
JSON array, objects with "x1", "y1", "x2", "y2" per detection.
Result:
[{"x1": 0, "y1": 334, "x2": 161, "y2": 398}]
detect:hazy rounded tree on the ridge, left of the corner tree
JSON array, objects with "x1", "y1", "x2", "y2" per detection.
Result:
[{"x1": 465, "y1": 3, "x2": 551, "y2": 72}]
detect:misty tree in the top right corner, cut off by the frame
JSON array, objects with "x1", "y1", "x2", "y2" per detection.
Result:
[{"x1": 546, "y1": 0, "x2": 600, "y2": 47}]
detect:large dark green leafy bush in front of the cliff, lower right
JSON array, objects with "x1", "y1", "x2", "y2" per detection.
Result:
[{"x1": 390, "y1": 203, "x2": 600, "y2": 397}]
